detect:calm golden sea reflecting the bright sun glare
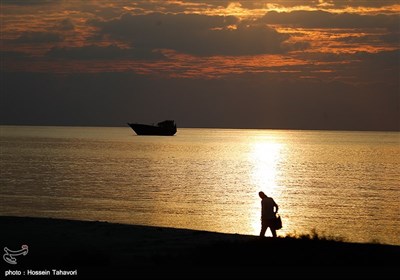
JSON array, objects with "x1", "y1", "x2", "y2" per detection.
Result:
[{"x1": 0, "y1": 126, "x2": 400, "y2": 245}]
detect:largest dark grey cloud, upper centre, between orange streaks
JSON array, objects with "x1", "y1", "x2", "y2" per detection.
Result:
[{"x1": 91, "y1": 13, "x2": 289, "y2": 56}]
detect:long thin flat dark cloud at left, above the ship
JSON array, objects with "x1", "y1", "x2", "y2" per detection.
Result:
[{"x1": 46, "y1": 45, "x2": 165, "y2": 60}]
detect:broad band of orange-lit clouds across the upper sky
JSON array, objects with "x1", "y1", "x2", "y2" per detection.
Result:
[{"x1": 0, "y1": 0, "x2": 400, "y2": 83}]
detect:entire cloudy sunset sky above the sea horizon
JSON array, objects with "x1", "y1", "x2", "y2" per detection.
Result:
[{"x1": 0, "y1": 0, "x2": 400, "y2": 131}]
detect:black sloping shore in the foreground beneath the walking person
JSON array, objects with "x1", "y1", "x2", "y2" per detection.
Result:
[{"x1": 0, "y1": 217, "x2": 400, "y2": 279}]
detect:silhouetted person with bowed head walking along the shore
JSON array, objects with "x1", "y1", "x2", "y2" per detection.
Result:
[{"x1": 258, "y1": 192, "x2": 279, "y2": 237}]
